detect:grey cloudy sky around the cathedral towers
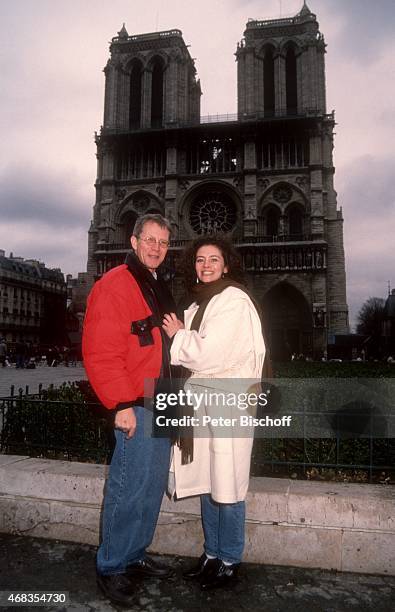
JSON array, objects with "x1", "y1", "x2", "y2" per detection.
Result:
[{"x1": 0, "y1": 0, "x2": 395, "y2": 328}]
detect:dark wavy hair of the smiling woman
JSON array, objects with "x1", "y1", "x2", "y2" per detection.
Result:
[{"x1": 182, "y1": 235, "x2": 245, "y2": 291}]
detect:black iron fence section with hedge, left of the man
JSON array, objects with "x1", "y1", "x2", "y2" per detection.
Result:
[{"x1": 0, "y1": 381, "x2": 114, "y2": 463}]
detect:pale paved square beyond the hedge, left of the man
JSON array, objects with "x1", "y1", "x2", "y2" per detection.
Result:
[{"x1": 0, "y1": 362, "x2": 86, "y2": 397}]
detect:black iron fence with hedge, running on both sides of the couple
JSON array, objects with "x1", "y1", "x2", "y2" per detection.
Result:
[{"x1": 0, "y1": 381, "x2": 395, "y2": 483}]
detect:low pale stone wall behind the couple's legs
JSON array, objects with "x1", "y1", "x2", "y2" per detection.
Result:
[{"x1": 0, "y1": 455, "x2": 395, "y2": 575}]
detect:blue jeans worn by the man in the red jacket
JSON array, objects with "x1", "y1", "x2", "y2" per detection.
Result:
[{"x1": 97, "y1": 406, "x2": 170, "y2": 575}]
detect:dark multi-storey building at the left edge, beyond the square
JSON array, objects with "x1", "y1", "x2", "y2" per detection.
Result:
[{"x1": 0, "y1": 250, "x2": 66, "y2": 345}]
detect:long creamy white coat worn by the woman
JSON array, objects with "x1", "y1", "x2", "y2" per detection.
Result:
[{"x1": 171, "y1": 287, "x2": 265, "y2": 503}]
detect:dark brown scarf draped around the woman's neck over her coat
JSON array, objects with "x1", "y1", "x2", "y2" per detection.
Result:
[{"x1": 178, "y1": 278, "x2": 273, "y2": 465}]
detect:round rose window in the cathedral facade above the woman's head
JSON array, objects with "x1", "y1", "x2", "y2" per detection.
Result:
[{"x1": 189, "y1": 191, "x2": 237, "y2": 234}]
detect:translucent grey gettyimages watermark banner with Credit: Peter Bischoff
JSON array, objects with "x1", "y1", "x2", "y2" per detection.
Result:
[{"x1": 145, "y1": 378, "x2": 395, "y2": 438}]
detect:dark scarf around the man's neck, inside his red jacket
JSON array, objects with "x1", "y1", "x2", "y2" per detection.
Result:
[{"x1": 125, "y1": 252, "x2": 176, "y2": 379}]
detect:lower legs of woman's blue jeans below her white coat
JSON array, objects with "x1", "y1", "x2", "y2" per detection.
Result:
[{"x1": 200, "y1": 494, "x2": 245, "y2": 563}]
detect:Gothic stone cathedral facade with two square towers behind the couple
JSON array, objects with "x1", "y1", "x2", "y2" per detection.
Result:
[{"x1": 88, "y1": 4, "x2": 348, "y2": 359}]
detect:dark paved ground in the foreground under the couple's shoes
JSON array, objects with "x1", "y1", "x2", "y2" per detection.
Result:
[{"x1": 0, "y1": 535, "x2": 395, "y2": 612}]
